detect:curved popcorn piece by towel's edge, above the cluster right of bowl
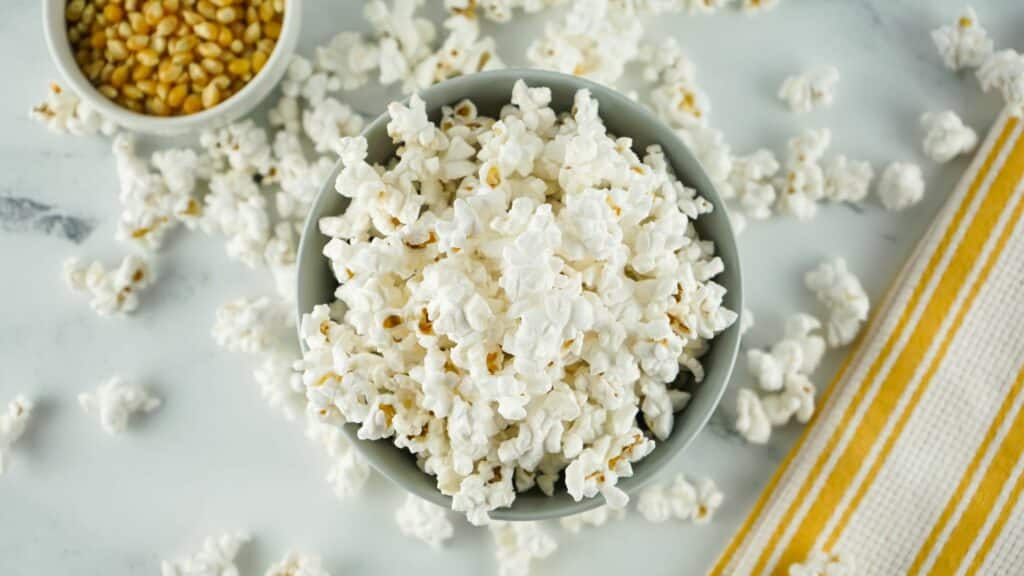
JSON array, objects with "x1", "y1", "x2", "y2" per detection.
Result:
[{"x1": 804, "y1": 257, "x2": 870, "y2": 347}]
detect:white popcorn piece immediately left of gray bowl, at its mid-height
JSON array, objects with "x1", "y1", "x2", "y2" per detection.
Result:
[{"x1": 210, "y1": 296, "x2": 287, "y2": 354}]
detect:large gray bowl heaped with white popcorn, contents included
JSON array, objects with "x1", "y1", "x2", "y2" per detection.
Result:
[{"x1": 297, "y1": 70, "x2": 742, "y2": 524}]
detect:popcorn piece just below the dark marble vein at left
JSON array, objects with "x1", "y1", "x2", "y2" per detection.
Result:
[{"x1": 63, "y1": 254, "x2": 155, "y2": 316}]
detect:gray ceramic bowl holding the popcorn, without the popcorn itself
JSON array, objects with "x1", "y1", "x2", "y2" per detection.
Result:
[{"x1": 298, "y1": 70, "x2": 743, "y2": 521}]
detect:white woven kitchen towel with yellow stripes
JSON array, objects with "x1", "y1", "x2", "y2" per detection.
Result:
[{"x1": 712, "y1": 108, "x2": 1024, "y2": 576}]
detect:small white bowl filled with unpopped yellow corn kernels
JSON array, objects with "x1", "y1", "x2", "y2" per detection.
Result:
[{"x1": 43, "y1": 0, "x2": 301, "y2": 134}]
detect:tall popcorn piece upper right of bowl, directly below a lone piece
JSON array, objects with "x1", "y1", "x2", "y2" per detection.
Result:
[{"x1": 776, "y1": 128, "x2": 831, "y2": 220}]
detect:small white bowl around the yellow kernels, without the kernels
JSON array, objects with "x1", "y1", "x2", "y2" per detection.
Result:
[{"x1": 43, "y1": 0, "x2": 302, "y2": 135}]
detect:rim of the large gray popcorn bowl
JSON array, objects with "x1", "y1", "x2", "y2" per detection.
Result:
[{"x1": 296, "y1": 68, "x2": 743, "y2": 521}]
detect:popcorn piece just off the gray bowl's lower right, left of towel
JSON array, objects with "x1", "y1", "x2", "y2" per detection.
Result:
[{"x1": 637, "y1": 474, "x2": 724, "y2": 524}]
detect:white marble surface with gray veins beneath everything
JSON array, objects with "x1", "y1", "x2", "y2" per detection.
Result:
[{"x1": 0, "y1": 0, "x2": 1024, "y2": 576}]
